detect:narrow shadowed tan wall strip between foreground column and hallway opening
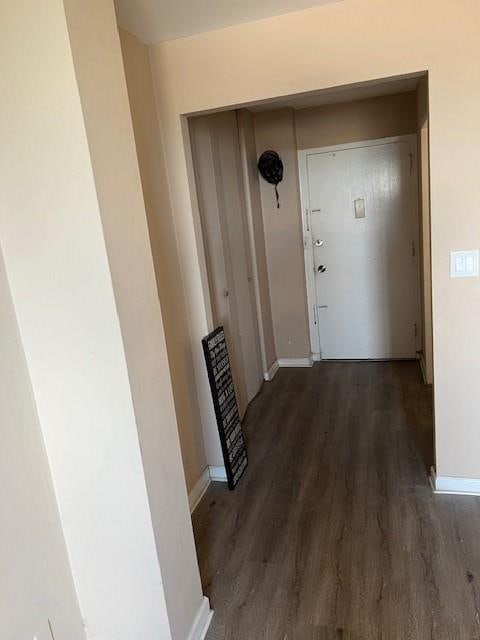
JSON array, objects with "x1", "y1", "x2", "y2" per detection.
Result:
[{"x1": 120, "y1": 29, "x2": 207, "y2": 491}]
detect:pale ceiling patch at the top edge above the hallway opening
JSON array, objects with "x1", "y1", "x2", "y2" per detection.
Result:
[{"x1": 115, "y1": 0, "x2": 341, "y2": 44}]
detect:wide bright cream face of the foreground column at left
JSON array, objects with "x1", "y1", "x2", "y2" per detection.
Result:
[{"x1": 0, "y1": 0, "x2": 168, "y2": 640}]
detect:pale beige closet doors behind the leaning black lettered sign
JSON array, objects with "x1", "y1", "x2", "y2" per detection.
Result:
[{"x1": 191, "y1": 112, "x2": 263, "y2": 416}]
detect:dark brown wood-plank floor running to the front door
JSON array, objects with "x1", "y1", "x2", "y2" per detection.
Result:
[{"x1": 193, "y1": 362, "x2": 480, "y2": 640}]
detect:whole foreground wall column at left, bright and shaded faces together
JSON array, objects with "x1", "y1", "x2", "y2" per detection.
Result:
[{"x1": 0, "y1": 0, "x2": 208, "y2": 640}]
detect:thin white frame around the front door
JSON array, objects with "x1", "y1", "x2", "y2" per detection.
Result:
[{"x1": 298, "y1": 133, "x2": 421, "y2": 360}]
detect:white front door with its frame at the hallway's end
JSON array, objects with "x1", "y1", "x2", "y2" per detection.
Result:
[{"x1": 300, "y1": 136, "x2": 420, "y2": 359}]
